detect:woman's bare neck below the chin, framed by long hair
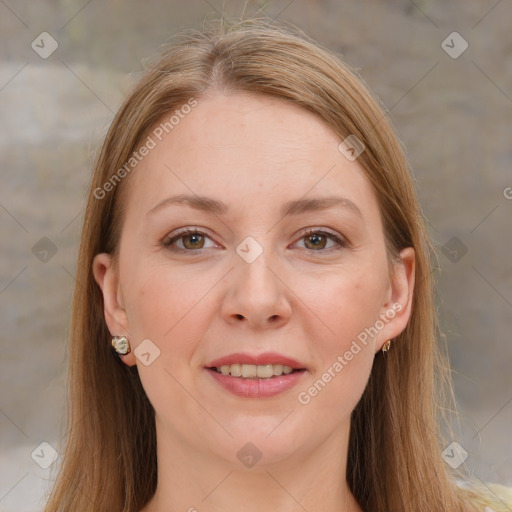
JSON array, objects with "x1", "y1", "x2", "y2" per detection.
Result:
[{"x1": 141, "y1": 419, "x2": 362, "y2": 512}]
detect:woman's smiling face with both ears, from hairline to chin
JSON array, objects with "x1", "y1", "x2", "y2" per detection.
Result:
[{"x1": 94, "y1": 93, "x2": 414, "y2": 465}]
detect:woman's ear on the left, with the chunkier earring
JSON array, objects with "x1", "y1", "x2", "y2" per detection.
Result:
[{"x1": 92, "y1": 253, "x2": 136, "y2": 366}]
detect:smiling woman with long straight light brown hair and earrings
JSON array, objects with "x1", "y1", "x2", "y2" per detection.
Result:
[{"x1": 46, "y1": 20, "x2": 510, "y2": 512}]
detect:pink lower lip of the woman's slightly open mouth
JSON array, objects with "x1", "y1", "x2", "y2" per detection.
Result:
[{"x1": 207, "y1": 368, "x2": 306, "y2": 398}]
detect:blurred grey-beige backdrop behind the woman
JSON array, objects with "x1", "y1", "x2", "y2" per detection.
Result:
[{"x1": 0, "y1": 0, "x2": 512, "y2": 512}]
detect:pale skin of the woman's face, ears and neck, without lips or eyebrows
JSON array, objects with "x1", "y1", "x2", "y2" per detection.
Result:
[{"x1": 93, "y1": 93, "x2": 414, "y2": 512}]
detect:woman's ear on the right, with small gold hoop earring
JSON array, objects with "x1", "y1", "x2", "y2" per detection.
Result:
[{"x1": 375, "y1": 247, "x2": 416, "y2": 352}]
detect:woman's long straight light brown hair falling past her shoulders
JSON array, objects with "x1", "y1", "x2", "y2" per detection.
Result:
[{"x1": 45, "y1": 19, "x2": 500, "y2": 512}]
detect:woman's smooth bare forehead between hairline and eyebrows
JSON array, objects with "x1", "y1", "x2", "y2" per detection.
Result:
[{"x1": 123, "y1": 93, "x2": 378, "y2": 224}]
